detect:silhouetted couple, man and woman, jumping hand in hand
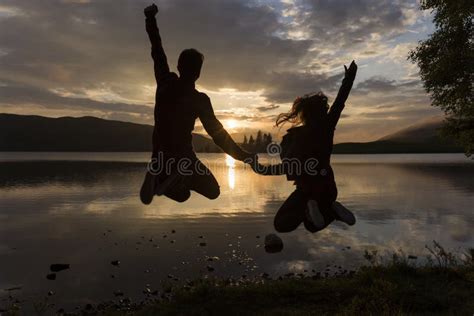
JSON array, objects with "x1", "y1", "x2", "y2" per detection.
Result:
[{"x1": 140, "y1": 5, "x2": 357, "y2": 232}]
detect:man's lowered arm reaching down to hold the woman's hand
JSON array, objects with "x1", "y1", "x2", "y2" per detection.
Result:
[{"x1": 199, "y1": 94, "x2": 254, "y2": 163}]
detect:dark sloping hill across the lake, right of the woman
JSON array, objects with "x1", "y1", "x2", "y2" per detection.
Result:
[{"x1": 334, "y1": 117, "x2": 463, "y2": 154}]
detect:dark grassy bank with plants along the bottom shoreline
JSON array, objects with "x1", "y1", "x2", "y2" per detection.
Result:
[{"x1": 2, "y1": 242, "x2": 474, "y2": 315}]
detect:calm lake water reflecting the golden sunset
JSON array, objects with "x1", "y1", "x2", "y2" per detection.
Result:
[{"x1": 0, "y1": 153, "x2": 474, "y2": 309}]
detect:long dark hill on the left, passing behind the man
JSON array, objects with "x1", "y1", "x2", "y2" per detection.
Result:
[{"x1": 0, "y1": 114, "x2": 219, "y2": 152}]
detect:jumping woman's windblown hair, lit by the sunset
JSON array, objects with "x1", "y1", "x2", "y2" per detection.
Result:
[{"x1": 276, "y1": 92, "x2": 328, "y2": 126}]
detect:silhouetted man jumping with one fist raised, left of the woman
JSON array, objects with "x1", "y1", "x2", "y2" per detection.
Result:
[{"x1": 140, "y1": 4, "x2": 255, "y2": 204}]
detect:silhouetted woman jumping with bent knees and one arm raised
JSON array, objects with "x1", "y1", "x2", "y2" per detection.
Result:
[{"x1": 255, "y1": 61, "x2": 357, "y2": 232}]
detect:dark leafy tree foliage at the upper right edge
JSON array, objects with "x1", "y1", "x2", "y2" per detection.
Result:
[{"x1": 409, "y1": 0, "x2": 474, "y2": 156}]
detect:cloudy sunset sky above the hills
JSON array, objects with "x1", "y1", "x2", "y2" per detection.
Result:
[{"x1": 0, "y1": 0, "x2": 440, "y2": 142}]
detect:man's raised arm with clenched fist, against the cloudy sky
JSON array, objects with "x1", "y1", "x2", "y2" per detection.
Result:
[{"x1": 144, "y1": 4, "x2": 170, "y2": 83}]
